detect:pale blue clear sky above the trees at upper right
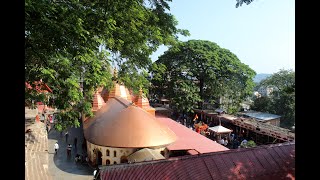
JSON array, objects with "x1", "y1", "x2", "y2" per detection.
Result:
[{"x1": 151, "y1": 0, "x2": 295, "y2": 74}]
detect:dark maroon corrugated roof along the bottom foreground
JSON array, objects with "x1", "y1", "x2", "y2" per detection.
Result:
[{"x1": 100, "y1": 143, "x2": 295, "y2": 180}]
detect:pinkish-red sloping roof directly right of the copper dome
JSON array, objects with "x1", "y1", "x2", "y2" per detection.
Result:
[{"x1": 156, "y1": 115, "x2": 229, "y2": 153}]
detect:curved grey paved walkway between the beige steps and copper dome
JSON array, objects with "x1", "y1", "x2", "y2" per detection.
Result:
[{"x1": 48, "y1": 123, "x2": 94, "y2": 180}]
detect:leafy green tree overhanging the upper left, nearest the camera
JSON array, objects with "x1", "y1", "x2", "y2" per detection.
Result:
[{"x1": 25, "y1": 0, "x2": 188, "y2": 130}]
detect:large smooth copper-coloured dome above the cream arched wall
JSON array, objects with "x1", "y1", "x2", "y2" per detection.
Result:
[{"x1": 84, "y1": 103, "x2": 176, "y2": 148}]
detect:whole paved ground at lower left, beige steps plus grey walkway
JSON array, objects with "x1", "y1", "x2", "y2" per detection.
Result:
[{"x1": 25, "y1": 108, "x2": 93, "y2": 180}]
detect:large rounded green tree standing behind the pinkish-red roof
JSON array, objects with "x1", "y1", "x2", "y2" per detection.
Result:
[{"x1": 152, "y1": 40, "x2": 255, "y2": 113}]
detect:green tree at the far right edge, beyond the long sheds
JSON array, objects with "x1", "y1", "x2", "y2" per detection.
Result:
[{"x1": 252, "y1": 69, "x2": 295, "y2": 129}]
